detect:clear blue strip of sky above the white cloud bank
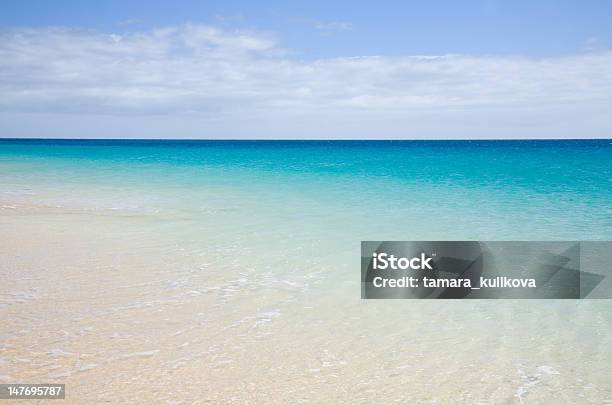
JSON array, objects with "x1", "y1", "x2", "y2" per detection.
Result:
[{"x1": 0, "y1": 0, "x2": 612, "y2": 58}]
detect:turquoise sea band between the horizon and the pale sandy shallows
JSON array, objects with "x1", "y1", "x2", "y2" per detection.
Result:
[{"x1": 0, "y1": 139, "x2": 612, "y2": 240}]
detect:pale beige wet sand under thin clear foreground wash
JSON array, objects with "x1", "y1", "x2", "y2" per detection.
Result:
[{"x1": 0, "y1": 204, "x2": 612, "y2": 404}]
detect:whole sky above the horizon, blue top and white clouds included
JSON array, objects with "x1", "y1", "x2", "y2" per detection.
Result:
[{"x1": 0, "y1": 0, "x2": 612, "y2": 139}]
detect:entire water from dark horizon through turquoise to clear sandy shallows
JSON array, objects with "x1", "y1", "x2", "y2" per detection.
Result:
[{"x1": 0, "y1": 139, "x2": 612, "y2": 403}]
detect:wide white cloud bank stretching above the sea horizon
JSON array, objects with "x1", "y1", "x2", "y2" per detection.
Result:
[{"x1": 0, "y1": 24, "x2": 612, "y2": 136}]
